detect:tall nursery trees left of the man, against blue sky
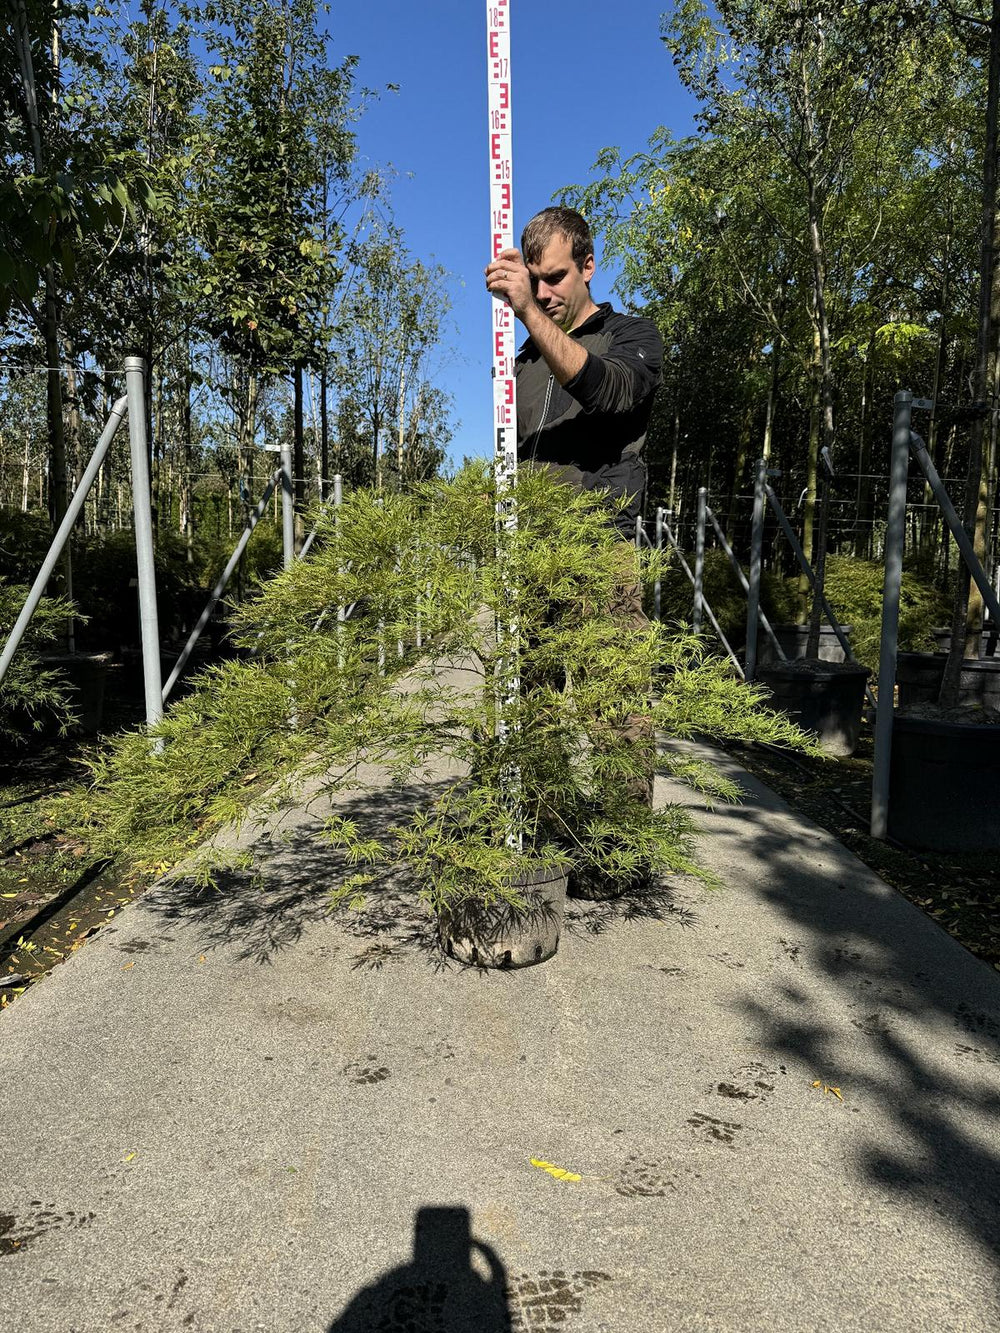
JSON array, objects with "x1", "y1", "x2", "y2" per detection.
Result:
[{"x1": 0, "y1": 0, "x2": 449, "y2": 583}]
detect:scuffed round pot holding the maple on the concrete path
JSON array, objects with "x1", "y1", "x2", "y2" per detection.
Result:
[{"x1": 437, "y1": 866, "x2": 567, "y2": 968}]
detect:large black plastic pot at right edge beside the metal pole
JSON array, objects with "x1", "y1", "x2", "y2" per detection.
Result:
[{"x1": 889, "y1": 714, "x2": 1000, "y2": 852}]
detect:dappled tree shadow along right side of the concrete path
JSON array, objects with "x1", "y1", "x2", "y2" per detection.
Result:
[{"x1": 708, "y1": 778, "x2": 1000, "y2": 1285}]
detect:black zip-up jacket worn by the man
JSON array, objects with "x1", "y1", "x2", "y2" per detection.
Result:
[{"x1": 515, "y1": 301, "x2": 663, "y2": 540}]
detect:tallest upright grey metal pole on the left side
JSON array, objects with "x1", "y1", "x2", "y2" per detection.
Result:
[{"x1": 125, "y1": 356, "x2": 163, "y2": 726}]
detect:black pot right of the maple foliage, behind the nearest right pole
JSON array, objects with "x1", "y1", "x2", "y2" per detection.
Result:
[{"x1": 757, "y1": 657, "x2": 871, "y2": 758}]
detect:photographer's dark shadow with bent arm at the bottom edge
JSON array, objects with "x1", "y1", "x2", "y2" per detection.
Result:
[{"x1": 328, "y1": 1208, "x2": 515, "y2": 1333}]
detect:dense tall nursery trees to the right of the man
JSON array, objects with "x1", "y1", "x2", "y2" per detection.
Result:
[{"x1": 565, "y1": 0, "x2": 1000, "y2": 631}]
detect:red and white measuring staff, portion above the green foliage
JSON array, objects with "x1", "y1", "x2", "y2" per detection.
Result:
[{"x1": 487, "y1": 0, "x2": 517, "y2": 501}]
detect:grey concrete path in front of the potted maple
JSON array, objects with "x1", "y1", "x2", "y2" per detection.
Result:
[{"x1": 0, "y1": 735, "x2": 1000, "y2": 1333}]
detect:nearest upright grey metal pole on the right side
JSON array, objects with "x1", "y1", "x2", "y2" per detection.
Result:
[{"x1": 871, "y1": 389, "x2": 913, "y2": 838}]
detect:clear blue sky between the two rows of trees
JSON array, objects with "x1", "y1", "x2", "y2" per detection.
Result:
[{"x1": 327, "y1": 0, "x2": 692, "y2": 461}]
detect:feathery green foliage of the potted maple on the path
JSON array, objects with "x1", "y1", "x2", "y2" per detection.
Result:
[{"x1": 64, "y1": 465, "x2": 809, "y2": 905}]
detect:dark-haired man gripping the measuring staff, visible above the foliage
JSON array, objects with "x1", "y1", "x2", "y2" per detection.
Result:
[{"x1": 485, "y1": 208, "x2": 663, "y2": 540}]
